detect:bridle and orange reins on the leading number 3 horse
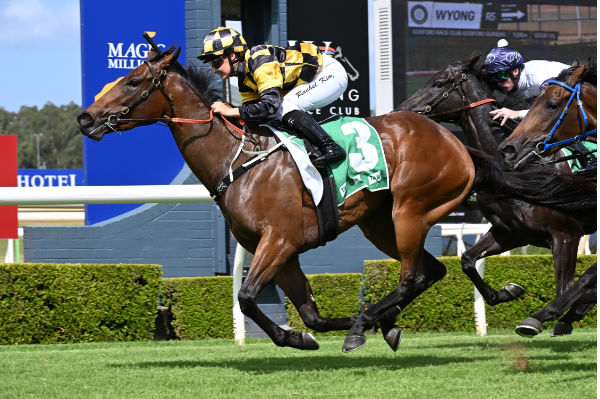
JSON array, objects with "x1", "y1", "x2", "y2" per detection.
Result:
[{"x1": 104, "y1": 60, "x2": 246, "y2": 135}]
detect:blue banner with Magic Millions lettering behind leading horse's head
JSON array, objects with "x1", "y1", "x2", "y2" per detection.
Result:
[{"x1": 80, "y1": 0, "x2": 186, "y2": 224}]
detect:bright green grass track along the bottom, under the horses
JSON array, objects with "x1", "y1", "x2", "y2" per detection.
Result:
[{"x1": 0, "y1": 329, "x2": 597, "y2": 399}]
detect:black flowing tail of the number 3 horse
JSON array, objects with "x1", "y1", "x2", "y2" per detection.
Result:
[{"x1": 467, "y1": 147, "x2": 597, "y2": 213}]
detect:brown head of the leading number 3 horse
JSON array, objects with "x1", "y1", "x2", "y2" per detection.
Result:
[{"x1": 77, "y1": 47, "x2": 181, "y2": 141}]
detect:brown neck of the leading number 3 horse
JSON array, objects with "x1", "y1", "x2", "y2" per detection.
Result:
[{"x1": 167, "y1": 75, "x2": 240, "y2": 194}]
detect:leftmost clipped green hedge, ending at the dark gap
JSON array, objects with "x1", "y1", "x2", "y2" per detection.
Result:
[{"x1": 0, "y1": 263, "x2": 161, "y2": 344}]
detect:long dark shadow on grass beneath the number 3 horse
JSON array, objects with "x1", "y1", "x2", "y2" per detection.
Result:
[{"x1": 110, "y1": 355, "x2": 494, "y2": 374}]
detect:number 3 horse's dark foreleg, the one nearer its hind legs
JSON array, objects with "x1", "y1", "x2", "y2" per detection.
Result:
[{"x1": 275, "y1": 256, "x2": 353, "y2": 332}]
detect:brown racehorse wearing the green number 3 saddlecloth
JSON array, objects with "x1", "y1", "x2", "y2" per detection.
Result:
[{"x1": 78, "y1": 44, "x2": 592, "y2": 351}]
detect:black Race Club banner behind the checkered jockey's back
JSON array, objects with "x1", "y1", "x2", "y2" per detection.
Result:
[{"x1": 287, "y1": 0, "x2": 370, "y2": 120}]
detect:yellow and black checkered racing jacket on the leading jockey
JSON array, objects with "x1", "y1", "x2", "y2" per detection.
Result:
[{"x1": 239, "y1": 42, "x2": 323, "y2": 102}]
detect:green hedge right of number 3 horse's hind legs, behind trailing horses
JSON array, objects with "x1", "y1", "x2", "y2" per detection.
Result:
[{"x1": 364, "y1": 255, "x2": 596, "y2": 331}]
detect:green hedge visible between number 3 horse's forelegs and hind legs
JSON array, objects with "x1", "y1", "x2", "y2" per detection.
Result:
[{"x1": 285, "y1": 273, "x2": 362, "y2": 335}]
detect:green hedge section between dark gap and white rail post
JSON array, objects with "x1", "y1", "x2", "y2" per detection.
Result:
[{"x1": 163, "y1": 276, "x2": 233, "y2": 339}]
